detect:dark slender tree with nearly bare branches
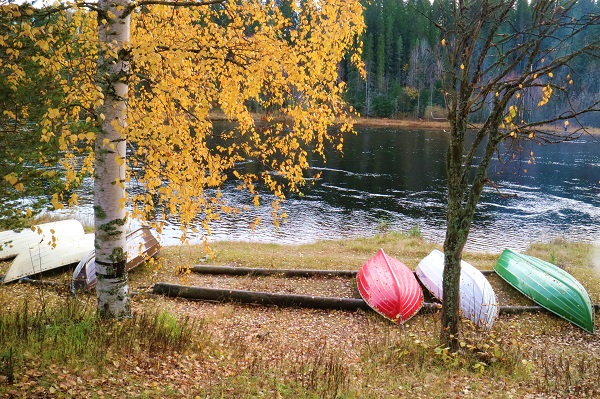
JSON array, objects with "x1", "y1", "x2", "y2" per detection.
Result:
[{"x1": 438, "y1": 0, "x2": 600, "y2": 349}]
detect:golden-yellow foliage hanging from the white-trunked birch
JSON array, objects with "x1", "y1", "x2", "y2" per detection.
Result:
[{"x1": 10, "y1": 0, "x2": 364, "y2": 231}]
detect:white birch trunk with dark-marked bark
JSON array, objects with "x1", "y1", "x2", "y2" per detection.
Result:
[{"x1": 94, "y1": 0, "x2": 131, "y2": 319}]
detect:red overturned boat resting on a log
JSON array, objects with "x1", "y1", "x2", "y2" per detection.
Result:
[{"x1": 356, "y1": 249, "x2": 423, "y2": 324}]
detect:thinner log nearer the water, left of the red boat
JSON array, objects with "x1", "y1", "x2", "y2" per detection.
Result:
[{"x1": 190, "y1": 265, "x2": 494, "y2": 278}]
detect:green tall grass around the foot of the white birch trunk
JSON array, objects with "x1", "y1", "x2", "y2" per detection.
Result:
[{"x1": 0, "y1": 297, "x2": 201, "y2": 374}]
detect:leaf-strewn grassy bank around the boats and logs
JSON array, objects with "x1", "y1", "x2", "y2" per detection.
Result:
[{"x1": 0, "y1": 233, "x2": 600, "y2": 398}]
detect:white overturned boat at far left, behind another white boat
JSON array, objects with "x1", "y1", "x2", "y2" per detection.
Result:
[{"x1": 0, "y1": 220, "x2": 85, "y2": 260}]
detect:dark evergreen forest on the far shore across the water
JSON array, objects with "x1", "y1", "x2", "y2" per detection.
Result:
[{"x1": 340, "y1": 0, "x2": 600, "y2": 127}]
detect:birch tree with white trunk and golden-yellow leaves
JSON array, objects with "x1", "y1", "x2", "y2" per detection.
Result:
[{"x1": 3, "y1": 0, "x2": 364, "y2": 319}]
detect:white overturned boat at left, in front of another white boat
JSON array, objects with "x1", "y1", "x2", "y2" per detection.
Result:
[{"x1": 3, "y1": 234, "x2": 94, "y2": 283}]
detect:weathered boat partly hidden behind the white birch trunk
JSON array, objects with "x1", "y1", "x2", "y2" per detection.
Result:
[{"x1": 71, "y1": 227, "x2": 160, "y2": 292}]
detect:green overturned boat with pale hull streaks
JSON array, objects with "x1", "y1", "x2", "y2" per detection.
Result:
[{"x1": 494, "y1": 249, "x2": 594, "y2": 334}]
